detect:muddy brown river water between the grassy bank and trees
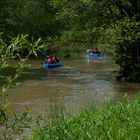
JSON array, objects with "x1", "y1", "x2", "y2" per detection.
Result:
[{"x1": 8, "y1": 55, "x2": 140, "y2": 115}]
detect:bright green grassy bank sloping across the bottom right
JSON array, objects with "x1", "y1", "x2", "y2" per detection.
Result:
[{"x1": 25, "y1": 96, "x2": 140, "y2": 140}]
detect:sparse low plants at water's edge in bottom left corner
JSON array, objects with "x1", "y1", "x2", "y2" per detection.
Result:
[{"x1": 1, "y1": 109, "x2": 33, "y2": 140}]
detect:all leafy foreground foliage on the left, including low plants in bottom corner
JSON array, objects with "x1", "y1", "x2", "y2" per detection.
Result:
[{"x1": 0, "y1": 35, "x2": 44, "y2": 139}]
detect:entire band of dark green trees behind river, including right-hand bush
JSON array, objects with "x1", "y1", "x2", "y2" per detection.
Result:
[{"x1": 0, "y1": 0, "x2": 140, "y2": 81}]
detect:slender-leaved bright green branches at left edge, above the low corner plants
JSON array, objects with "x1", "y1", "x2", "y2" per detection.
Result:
[{"x1": 0, "y1": 35, "x2": 44, "y2": 123}]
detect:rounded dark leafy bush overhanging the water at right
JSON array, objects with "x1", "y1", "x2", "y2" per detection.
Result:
[{"x1": 105, "y1": 18, "x2": 140, "y2": 81}]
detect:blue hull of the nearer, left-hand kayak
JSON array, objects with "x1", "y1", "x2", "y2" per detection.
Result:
[{"x1": 43, "y1": 61, "x2": 63, "y2": 70}]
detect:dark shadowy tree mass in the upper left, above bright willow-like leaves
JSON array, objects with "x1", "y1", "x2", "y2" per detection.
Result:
[{"x1": 0, "y1": 0, "x2": 60, "y2": 38}]
